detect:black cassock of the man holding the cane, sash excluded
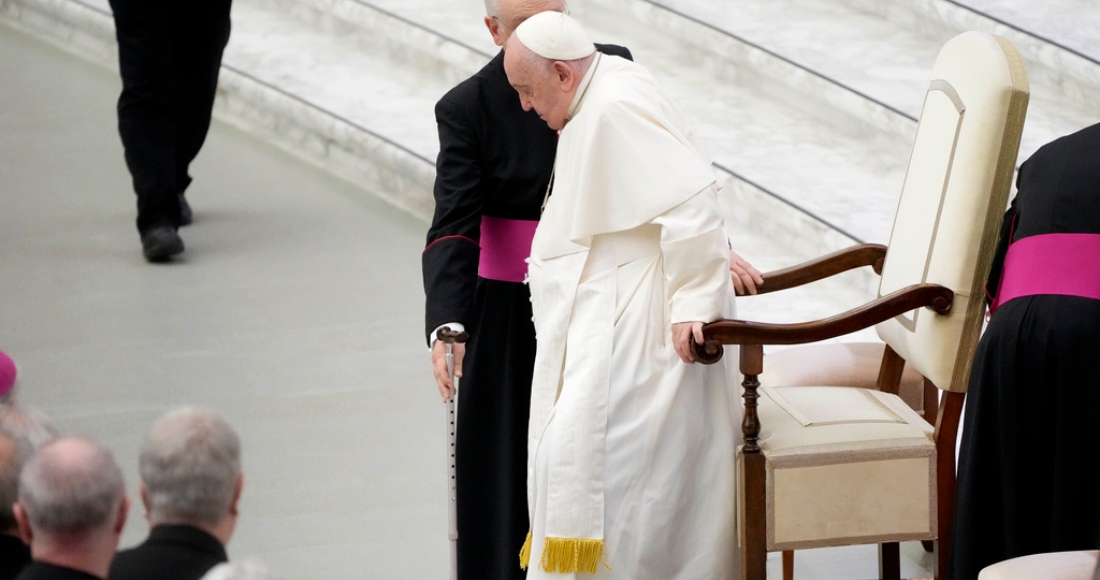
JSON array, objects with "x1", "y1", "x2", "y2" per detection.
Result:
[{"x1": 422, "y1": 45, "x2": 630, "y2": 580}]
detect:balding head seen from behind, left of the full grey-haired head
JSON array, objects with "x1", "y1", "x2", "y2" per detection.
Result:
[{"x1": 19, "y1": 437, "x2": 125, "y2": 536}]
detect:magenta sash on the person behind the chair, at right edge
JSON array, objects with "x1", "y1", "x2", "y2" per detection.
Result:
[{"x1": 989, "y1": 233, "x2": 1100, "y2": 314}]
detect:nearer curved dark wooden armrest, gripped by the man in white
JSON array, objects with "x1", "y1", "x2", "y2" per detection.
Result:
[{"x1": 695, "y1": 284, "x2": 955, "y2": 364}]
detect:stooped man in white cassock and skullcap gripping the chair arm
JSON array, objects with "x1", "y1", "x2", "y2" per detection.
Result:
[{"x1": 505, "y1": 12, "x2": 739, "y2": 580}]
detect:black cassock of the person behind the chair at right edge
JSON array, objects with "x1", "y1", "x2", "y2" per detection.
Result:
[{"x1": 954, "y1": 124, "x2": 1100, "y2": 580}]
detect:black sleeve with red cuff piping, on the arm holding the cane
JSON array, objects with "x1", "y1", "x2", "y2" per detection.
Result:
[{"x1": 421, "y1": 86, "x2": 482, "y2": 343}]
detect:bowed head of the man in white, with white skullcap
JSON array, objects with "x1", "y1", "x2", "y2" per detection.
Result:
[{"x1": 504, "y1": 11, "x2": 596, "y2": 130}]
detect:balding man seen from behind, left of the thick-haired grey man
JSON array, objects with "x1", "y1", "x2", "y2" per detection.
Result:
[{"x1": 12, "y1": 438, "x2": 130, "y2": 580}]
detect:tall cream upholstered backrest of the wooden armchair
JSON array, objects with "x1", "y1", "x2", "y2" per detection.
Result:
[{"x1": 877, "y1": 32, "x2": 1029, "y2": 392}]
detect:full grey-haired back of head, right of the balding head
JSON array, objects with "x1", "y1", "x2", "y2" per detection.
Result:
[{"x1": 139, "y1": 407, "x2": 241, "y2": 526}]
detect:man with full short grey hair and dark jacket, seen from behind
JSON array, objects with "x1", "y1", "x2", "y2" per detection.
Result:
[{"x1": 109, "y1": 407, "x2": 244, "y2": 580}]
